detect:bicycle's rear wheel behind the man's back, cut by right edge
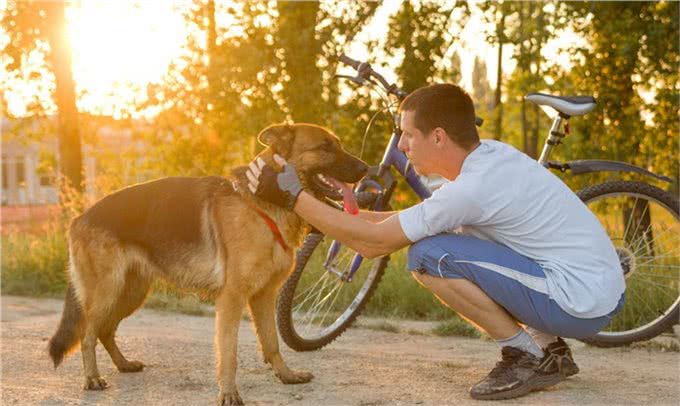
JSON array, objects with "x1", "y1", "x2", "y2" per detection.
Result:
[{"x1": 577, "y1": 180, "x2": 680, "y2": 347}]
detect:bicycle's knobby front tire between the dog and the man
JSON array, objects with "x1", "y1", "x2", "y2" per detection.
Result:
[{"x1": 277, "y1": 192, "x2": 389, "y2": 351}]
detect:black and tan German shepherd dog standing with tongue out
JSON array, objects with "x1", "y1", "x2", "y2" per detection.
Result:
[{"x1": 48, "y1": 124, "x2": 368, "y2": 405}]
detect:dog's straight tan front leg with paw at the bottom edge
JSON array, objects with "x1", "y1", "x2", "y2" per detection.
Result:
[{"x1": 215, "y1": 288, "x2": 245, "y2": 406}]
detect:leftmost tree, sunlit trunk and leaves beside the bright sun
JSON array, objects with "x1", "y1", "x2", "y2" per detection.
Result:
[{"x1": 2, "y1": 1, "x2": 83, "y2": 196}]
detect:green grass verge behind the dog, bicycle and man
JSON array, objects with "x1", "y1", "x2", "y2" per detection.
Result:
[{"x1": 0, "y1": 205, "x2": 680, "y2": 337}]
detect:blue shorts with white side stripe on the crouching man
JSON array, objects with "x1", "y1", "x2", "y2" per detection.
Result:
[{"x1": 408, "y1": 234, "x2": 624, "y2": 338}]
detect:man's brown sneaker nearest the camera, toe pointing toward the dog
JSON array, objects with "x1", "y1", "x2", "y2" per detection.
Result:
[{"x1": 470, "y1": 347, "x2": 565, "y2": 400}]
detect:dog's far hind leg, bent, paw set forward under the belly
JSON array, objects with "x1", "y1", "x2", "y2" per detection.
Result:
[{"x1": 99, "y1": 266, "x2": 151, "y2": 372}]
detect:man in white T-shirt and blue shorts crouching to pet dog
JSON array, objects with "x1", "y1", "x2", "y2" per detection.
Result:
[{"x1": 249, "y1": 84, "x2": 625, "y2": 399}]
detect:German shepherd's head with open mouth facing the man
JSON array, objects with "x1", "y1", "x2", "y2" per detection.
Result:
[{"x1": 258, "y1": 124, "x2": 368, "y2": 201}]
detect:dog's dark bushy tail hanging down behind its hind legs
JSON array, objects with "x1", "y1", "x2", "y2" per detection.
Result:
[{"x1": 47, "y1": 282, "x2": 85, "y2": 368}]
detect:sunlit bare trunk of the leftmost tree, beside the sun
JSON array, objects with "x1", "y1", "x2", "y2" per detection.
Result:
[{"x1": 45, "y1": 1, "x2": 84, "y2": 196}]
